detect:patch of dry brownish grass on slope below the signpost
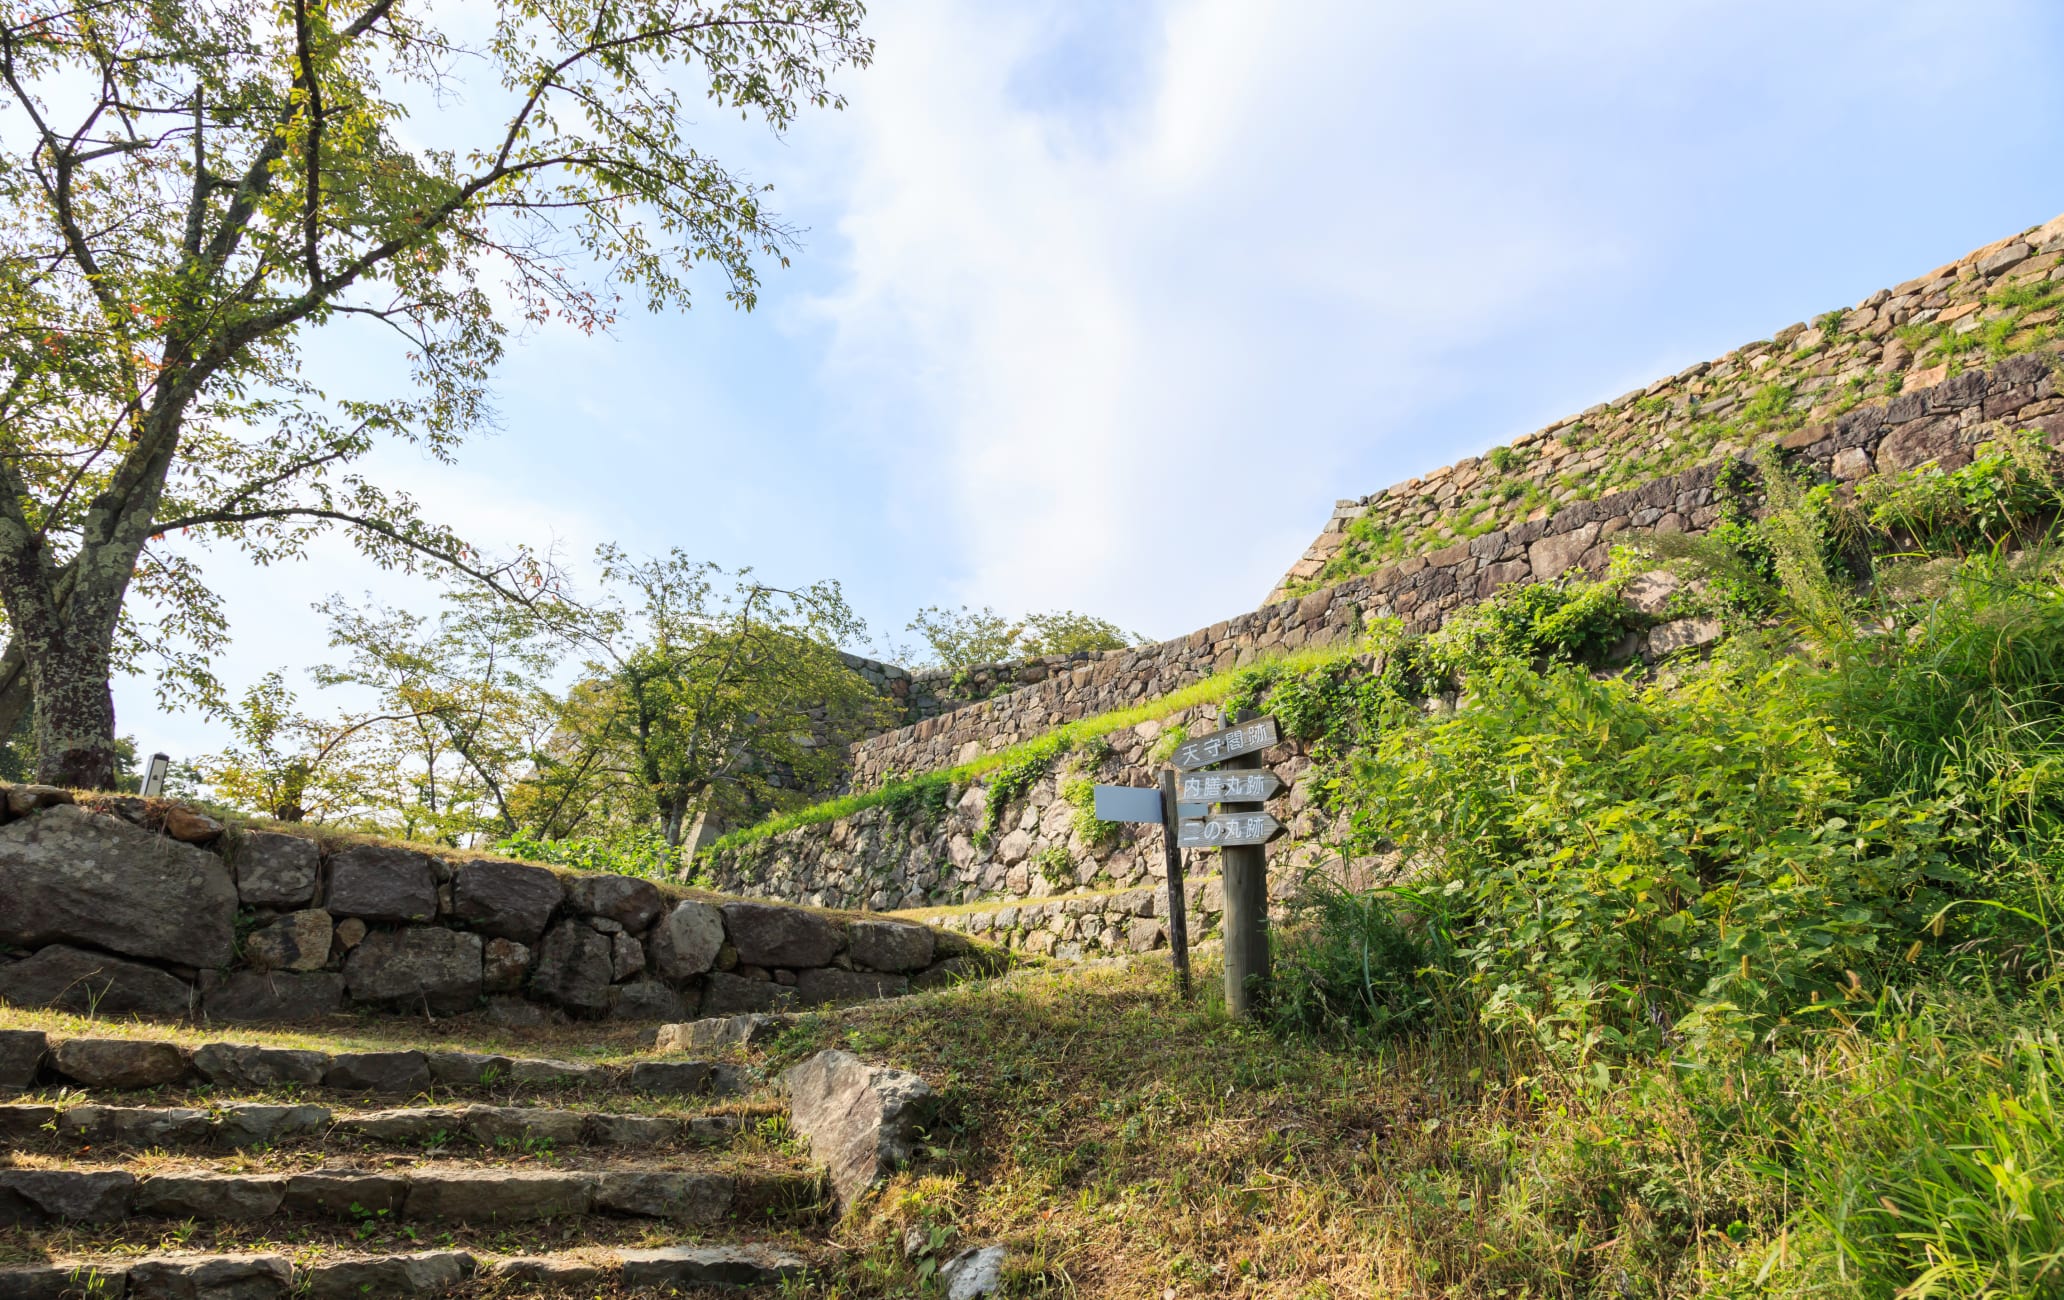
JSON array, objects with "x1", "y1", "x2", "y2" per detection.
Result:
[{"x1": 743, "y1": 962, "x2": 1775, "y2": 1298}]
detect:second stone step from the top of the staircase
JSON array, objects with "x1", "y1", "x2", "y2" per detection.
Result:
[{"x1": 0, "y1": 1102, "x2": 749, "y2": 1151}]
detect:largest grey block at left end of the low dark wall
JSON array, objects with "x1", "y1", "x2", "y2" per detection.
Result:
[{"x1": 0, "y1": 805, "x2": 237, "y2": 966}]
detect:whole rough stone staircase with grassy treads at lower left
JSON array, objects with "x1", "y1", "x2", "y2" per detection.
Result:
[{"x1": 0, "y1": 1026, "x2": 854, "y2": 1300}]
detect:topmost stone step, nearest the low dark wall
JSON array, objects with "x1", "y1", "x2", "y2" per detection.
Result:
[{"x1": 0, "y1": 1030, "x2": 753, "y2": 1096}]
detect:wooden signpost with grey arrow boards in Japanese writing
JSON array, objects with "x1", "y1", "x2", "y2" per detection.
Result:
[{"x1": 1096, "y1": 712, "x2": 1284, "y2": 1017}]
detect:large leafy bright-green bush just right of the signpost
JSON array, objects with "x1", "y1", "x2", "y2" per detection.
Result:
[{"x1": 1352, "y1": 658, "x2": 1961, "y2": 1061}]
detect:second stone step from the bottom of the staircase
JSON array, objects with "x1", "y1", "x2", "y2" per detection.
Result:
[{"x1": 0, "y1": 1162, "x2": 824, "y2": 1229}]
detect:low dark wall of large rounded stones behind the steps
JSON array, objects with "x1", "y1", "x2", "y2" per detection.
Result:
[{"x1": 0, "y1": 786, "x2": 989, "y2": 1023}]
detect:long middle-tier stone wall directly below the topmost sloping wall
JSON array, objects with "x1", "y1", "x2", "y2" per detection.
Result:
[{"x1": 852, "y1": 349, "x2": 2064, "y2": 790}]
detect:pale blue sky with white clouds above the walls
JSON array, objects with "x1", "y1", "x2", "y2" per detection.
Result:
[{"x1": 118, "y1": 0, "x2": 2064, "y2": 757}]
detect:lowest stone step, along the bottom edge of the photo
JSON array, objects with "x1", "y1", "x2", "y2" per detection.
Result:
[{"x1": 0, "y1": 1242, "x2": 811, "y2": 1300}]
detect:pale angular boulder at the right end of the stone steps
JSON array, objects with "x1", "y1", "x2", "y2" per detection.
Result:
[{"x1": 782, "y1": 1050, "x2": 937, "y2": 1209}]
